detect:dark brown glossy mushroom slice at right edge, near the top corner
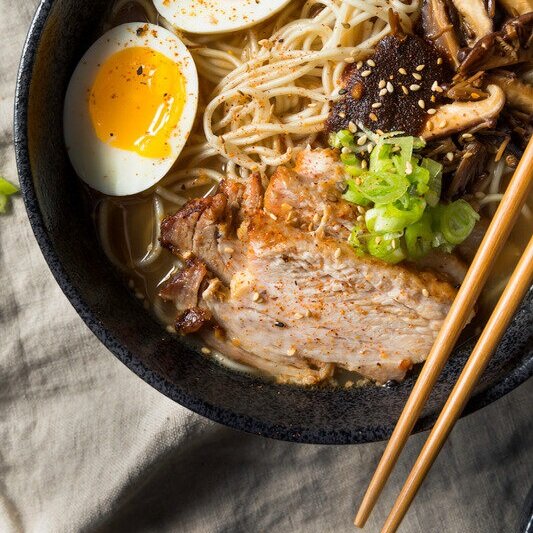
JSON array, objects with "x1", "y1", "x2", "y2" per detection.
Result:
[{"x1": 459, "y1": 12, "x2": 533, "y2": 75}]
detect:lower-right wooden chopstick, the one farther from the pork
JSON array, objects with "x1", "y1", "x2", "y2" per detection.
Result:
[{"x1": 382, "y1": 237, "x2": 533, "y2": 533}]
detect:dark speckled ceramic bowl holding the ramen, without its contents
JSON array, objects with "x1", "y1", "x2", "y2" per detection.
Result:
[{"x1": 15, "y1": 0, "x2": 533, "y2": 444}]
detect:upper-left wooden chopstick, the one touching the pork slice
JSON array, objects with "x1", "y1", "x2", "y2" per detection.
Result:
[{"x1": 354, "y1": 138, "x2": 533, "y2": 527}]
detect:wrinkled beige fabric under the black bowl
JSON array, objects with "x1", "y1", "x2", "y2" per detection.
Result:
[{"x1": 0, "y1": 0, "x2": 533, "y2": 533}]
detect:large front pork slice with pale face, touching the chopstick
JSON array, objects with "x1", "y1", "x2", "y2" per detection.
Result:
[{"x1": 203, "y1": 213, "x2": 455, "y2": 382}]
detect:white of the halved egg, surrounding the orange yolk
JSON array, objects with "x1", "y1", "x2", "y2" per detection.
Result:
[{"x1": 63, "y1": 23, "x2": 198, "y2": 196}]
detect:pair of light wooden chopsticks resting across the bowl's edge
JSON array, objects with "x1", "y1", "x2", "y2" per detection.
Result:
[{"x1": 355, "y1": 138, "x2": 533, "y2": 533}]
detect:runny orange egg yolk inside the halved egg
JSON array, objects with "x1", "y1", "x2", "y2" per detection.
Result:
[{"x1": 89, "y1": 47, "x2": 186, "y2": 158}]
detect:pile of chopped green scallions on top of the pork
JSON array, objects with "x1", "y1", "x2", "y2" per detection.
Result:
[{"x1": 330, "y1": 130, "x2": 479, "y2": 263}]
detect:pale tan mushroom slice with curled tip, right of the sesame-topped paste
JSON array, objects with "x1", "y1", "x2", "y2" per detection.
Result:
[{"x1": 422, "y1": 84, "x2": 505, "y2": 140}]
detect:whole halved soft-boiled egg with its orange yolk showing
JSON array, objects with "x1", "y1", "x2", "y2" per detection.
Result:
[{"x1": 63, "y1": 23, "x2": 198, "y2": 196}]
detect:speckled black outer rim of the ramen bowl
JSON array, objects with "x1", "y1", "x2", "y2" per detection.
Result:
[{"x1": 13, "y1": 0, "x2": 533, "y2": 444}]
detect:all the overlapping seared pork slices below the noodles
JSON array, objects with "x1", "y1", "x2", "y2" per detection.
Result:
[{"x1": 161, "y1": 150, "x2": 455, "y2": 384}]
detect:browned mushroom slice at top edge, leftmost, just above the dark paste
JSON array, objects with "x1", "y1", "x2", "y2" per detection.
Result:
[{"x1": 422, "y1": 0, "x2": 459, "y2": 70}]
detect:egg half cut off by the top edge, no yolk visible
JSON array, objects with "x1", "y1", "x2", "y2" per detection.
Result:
[{"x1": 154, "y1": 0, "x2": 290, "y2": 34}]
